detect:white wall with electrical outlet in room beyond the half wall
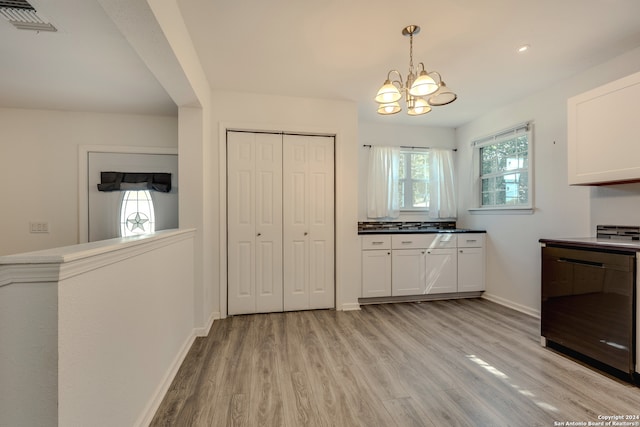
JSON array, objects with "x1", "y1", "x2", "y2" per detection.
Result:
[{"x1": 0, "y1": 108, "x2": 178, "y2": 255}]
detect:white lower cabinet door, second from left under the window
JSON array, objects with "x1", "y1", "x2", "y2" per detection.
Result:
[{"x1": 391, "y1": 249, "x2": 426, "y2": 296}]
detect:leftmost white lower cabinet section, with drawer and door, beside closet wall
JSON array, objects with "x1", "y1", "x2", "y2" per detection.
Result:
[{"x1": 362, "y1": 236, "x2": 391, "y2": 298}]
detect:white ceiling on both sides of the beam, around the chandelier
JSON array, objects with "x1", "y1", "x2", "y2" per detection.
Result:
[{"x1": 0, "y1": 0, "x2": 640, "y2": 127}]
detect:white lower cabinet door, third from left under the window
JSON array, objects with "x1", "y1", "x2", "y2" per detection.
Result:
[{"x1": 425, "y1": 249, "x2": 458, "y2": 294}]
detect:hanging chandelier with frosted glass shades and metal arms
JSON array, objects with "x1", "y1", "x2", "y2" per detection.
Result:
[{"x1": 375, "y1": 25, "x2": 458, "y2": 116}]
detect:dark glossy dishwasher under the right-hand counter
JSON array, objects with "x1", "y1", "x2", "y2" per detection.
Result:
[{"x1": 541, "y1": 244, "x2": 635, "y2": 375}]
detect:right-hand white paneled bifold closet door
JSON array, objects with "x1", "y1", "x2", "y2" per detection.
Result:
[{"x1": 283, "y1": 134, "x2": 335, "y2": 311}]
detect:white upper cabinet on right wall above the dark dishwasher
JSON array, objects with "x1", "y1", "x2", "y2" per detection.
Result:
[{"x1": 567, "y1": 72, "x2": 640, "y2": 185}]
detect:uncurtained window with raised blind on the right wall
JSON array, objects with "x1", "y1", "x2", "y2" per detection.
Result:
[{"x1": 474, "y1": 124, "x2": 532, "y2": 208}]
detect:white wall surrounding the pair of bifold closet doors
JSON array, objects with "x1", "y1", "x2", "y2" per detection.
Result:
[{"x1": 210, "y1": 92, "x2": 360, "y2": 315}]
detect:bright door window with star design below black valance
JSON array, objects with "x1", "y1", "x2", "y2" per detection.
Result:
[{"x1": 120, "y1": 190, "x2": 156, "y2": 237}]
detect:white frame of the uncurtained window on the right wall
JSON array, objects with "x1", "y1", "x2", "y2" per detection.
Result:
[{"x1": 468, "y1": 122, "x2": 535, "y2": 214}]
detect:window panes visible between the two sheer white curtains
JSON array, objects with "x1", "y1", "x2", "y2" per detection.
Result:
[{"x1": 398, "y1": 150, "x2": 429, "y2": 211}]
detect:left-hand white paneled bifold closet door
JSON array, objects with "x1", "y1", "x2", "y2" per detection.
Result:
[{"x1": 227, "y1": 131, "x2": 283, "y2": 315}]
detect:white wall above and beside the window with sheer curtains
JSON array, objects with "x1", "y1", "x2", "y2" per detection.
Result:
[{"x1": 358, "y1": 120, "x2": 457, "y2": 221}]
